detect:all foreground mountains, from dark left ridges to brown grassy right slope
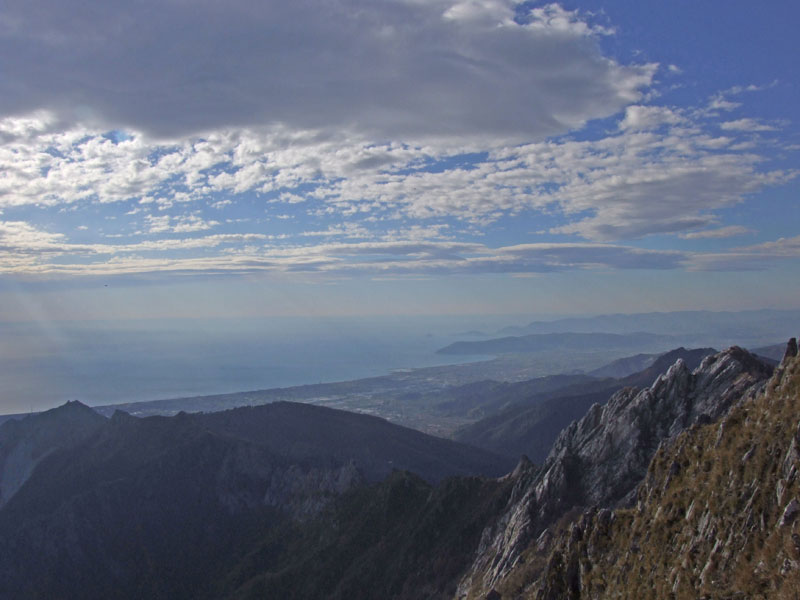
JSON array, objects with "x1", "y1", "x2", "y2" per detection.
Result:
[{"x1": 0, "y1": 341, "x2": 800, "y2": 600}]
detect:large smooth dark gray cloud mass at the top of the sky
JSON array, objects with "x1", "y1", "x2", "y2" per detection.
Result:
[{"x1": 0, "y1": 0, "x2": 656, "y2": 141}]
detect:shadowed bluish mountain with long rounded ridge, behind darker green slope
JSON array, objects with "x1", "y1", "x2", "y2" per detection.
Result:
[{"x1": 0, "y1": 403, "x2": 504, "y2": 600}]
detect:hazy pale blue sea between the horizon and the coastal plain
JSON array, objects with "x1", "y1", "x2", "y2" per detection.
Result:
[{"x1": 0, "y1": 315, "x2": 512, "y2": 413}]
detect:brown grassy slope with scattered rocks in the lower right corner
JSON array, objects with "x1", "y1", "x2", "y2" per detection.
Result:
[{"x1": 526, "y1": 340, "x2": 800, "y2": 600}]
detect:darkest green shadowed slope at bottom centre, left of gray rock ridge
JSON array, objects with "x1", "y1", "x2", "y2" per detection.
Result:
[{"x1": 224, "y1": 471, "x2": 510, "y2": 600}]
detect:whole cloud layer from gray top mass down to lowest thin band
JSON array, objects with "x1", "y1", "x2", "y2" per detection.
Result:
[{"x1": 0, "y1": 0, "x2": 799, "y2": 277}]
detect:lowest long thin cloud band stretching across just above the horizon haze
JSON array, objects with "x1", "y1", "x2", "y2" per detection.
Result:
[{"x1": 9, "y1": 216, "x2": 800, "y2": 278}]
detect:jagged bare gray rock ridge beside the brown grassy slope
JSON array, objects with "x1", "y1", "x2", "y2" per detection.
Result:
[{"x1": 459, "y1": 346, "x2": 771, "y2": 597}]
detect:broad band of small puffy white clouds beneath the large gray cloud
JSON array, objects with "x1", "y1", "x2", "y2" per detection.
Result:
[{"x1": 0, "y1": 99, "x2": 797, "y2": 247}]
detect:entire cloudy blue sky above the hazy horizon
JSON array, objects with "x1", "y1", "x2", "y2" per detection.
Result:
[{"x1": 0, "y1": 0, "x2": 800, "y2": 321}]
